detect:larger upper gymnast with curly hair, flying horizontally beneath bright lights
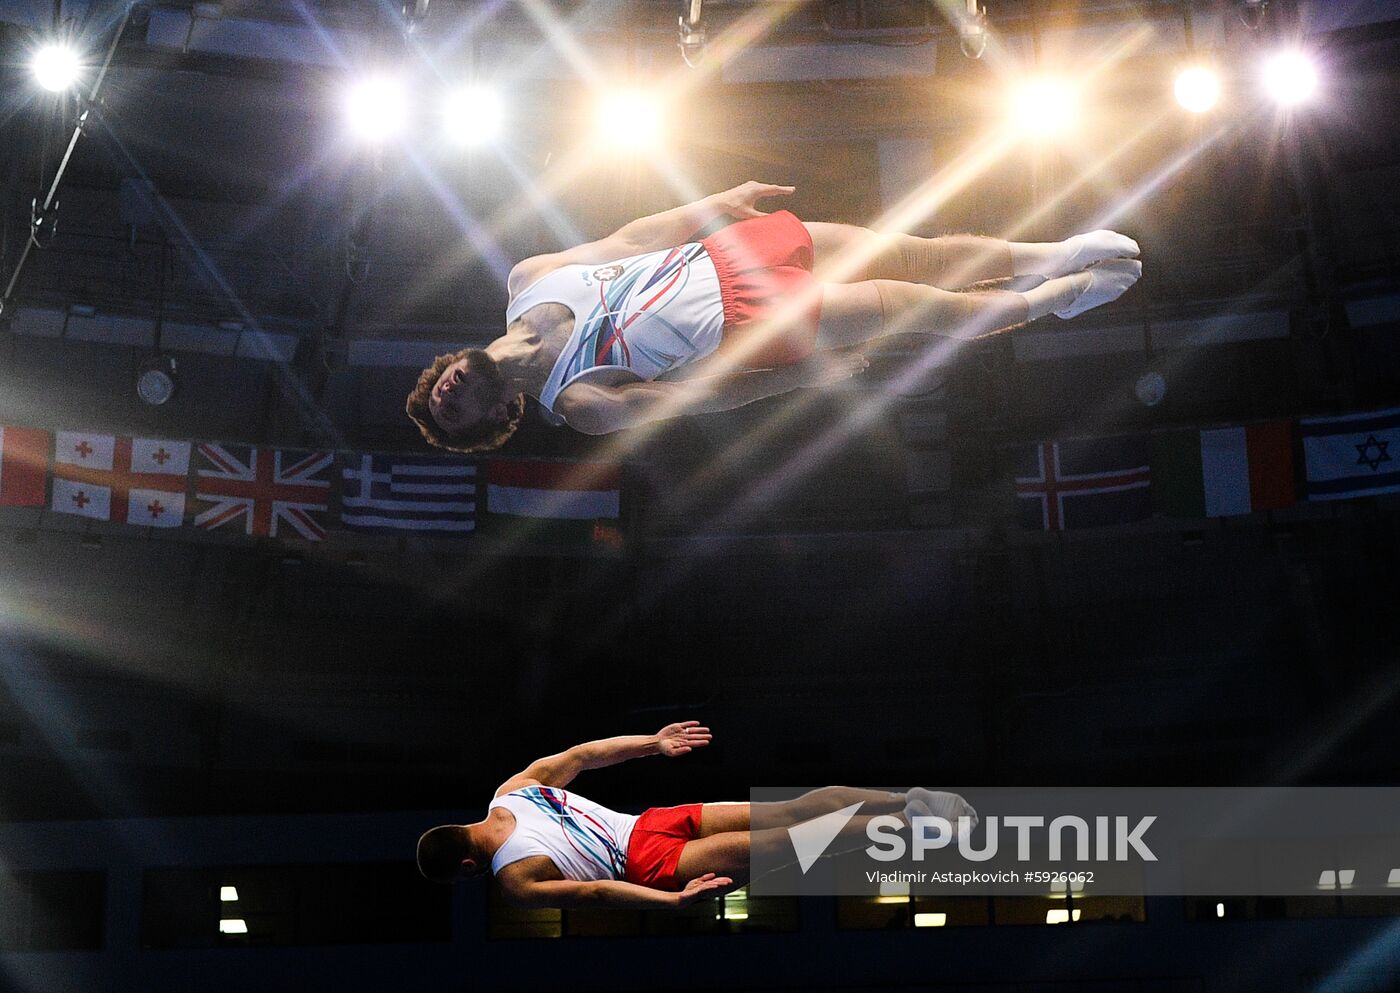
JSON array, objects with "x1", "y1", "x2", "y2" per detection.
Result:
[{"x1": 407, "y1": 182, "x2": 1142, "y2": 452}]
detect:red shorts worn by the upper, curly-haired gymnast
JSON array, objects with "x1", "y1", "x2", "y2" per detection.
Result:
[{"x1": 700, "y1": 210, "x2": 822, "y2": 368}]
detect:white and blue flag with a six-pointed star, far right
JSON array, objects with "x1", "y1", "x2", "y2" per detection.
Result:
[{"x1": 1298, "y1": 408, "x2": 1400, "y2": 500}]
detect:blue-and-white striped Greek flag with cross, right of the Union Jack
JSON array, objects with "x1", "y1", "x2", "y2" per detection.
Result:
[{"x1": 340, "y1": 454, "x2": 476, "y2": 535}]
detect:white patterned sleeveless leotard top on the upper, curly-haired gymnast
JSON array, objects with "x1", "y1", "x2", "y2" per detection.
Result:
[{"x1": 505, "y1": 242, "x2": 724, "y2": 410}]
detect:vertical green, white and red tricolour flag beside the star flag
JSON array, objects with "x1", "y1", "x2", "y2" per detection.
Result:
[{"x1": 1152, "y1": 420, "x2": 1298, "y2": 517}]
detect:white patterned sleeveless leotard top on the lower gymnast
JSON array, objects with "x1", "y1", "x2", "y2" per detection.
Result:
[{"x1": 491, "y1": 786, "x2": 637, "y2": 882}]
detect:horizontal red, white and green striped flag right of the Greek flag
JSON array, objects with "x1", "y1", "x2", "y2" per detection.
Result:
[{"x1": 482, "y1": 459, "x2": 622, "y2": 542}]
